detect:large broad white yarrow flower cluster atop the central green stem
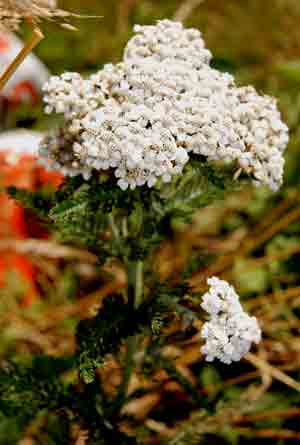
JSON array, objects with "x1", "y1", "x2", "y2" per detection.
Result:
[{"x1": 42, "y1": 20, "x2": 288, "y2": 190}]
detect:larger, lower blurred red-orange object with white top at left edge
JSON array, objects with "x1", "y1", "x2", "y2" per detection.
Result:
[{"x1": 0, "y1": 130, "x2": 63, "y2": 305}]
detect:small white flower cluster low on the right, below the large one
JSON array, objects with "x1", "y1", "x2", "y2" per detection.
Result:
[{"x1": 201, "y1": 277, "x2": 261, "y2": 364}]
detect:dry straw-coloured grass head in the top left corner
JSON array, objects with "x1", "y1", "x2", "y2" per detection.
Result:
[{"x1": 0, "y1": 0, "x2": 74, "y2": 30}]
